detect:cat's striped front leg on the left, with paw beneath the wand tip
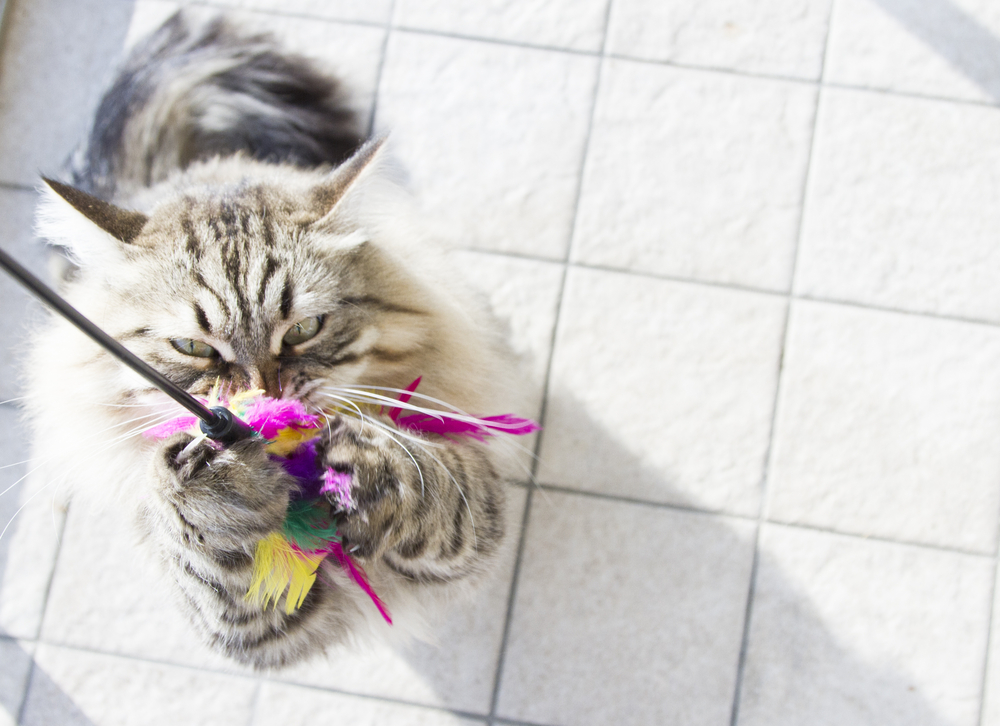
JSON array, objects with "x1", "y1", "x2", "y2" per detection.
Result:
[{"x1": 142, "y1": 434, "x2": 342, "y2": 667}]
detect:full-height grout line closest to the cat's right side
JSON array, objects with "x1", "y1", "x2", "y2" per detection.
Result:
[{"x1": 489, "y1": 0, "x2": 613, "y2": 724}]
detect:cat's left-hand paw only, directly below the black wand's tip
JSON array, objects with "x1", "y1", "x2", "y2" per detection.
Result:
[{"x1": 152, "y1": 434, "x2": 292, "y2": 546}]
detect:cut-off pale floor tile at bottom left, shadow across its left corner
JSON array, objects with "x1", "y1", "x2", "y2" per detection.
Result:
[{"x1": 23, "y1": 645, "x2": 256, "y2": 726}]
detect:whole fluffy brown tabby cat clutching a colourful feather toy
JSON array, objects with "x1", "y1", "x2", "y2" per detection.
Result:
[{"x1": 21, "y1": 13, "x2": 524, "y2": 669}]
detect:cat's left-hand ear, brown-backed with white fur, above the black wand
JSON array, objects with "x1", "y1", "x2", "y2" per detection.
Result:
[{"x1": 37, "y1": 177, "x2": 148, "y2": 265}]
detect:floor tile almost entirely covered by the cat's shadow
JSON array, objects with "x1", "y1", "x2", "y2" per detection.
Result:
[{"x1": 498, "y1": 492, "x2": 754, "y2": 726}]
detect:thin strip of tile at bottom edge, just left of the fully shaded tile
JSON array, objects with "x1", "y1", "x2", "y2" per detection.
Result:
[{"x1": 253, "y1": 683, "x2": 480, "y2": 726}]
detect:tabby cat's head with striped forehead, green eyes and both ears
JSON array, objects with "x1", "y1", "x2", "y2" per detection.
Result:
[{"x1": 32, "y1": 142, "x2": 446, "y2": 420}]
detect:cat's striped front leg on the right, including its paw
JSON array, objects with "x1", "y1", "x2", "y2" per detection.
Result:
[{"x1": 320, "y1": 417, "x2": 505, "y2": 582}]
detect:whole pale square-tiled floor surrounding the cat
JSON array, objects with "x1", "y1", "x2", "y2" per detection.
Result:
[{"x1": 0, "y1": 0, "x2": 1000, "y2": 726}]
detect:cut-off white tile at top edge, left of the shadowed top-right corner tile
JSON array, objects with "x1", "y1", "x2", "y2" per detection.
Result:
[{"x1": 608, "y1": 0, "x2": 831, "y2": 79}]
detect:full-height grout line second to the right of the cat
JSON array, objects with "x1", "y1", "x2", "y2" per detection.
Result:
[{"x1": 729, "y1": 9, "x2": 833, "y2": 726}]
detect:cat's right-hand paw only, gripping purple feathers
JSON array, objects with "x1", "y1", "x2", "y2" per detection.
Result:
[{"x1": 319, "y1": 417, "x2": 416, "y2": 558}]
